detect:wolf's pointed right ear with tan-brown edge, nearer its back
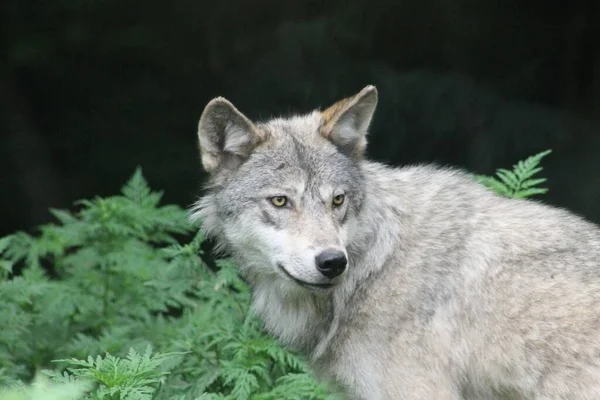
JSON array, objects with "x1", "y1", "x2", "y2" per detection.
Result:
[{"x1": 321, "y1": 85, "x2": 377, "y2": 158}]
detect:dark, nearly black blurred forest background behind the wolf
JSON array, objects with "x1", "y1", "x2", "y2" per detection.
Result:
[{"x1": 0, "y1": 0, "x2": 600, "y2": 235}]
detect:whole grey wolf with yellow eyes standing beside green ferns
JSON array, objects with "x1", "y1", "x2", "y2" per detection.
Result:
[{"x1": 191, "y1": 86, "x2": 600, "y2": 400}]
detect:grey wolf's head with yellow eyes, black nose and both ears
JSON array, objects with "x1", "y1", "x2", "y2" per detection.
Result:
[{"x1": 193, "y1": 86, "x2": 377, "y2": 291}]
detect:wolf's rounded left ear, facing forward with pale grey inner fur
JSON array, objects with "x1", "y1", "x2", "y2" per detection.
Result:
[{"x1": 198, "y1": 97, "x2": 264, "y2": 173}]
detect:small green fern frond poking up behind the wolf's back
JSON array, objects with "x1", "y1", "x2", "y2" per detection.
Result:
[{"x1": 475, "y1": 150, "x2": 552, "y2": 199}]
